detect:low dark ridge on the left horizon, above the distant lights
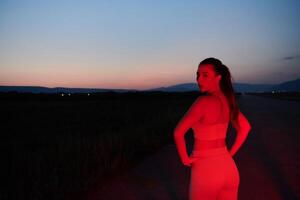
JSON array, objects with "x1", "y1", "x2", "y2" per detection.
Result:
[{"x1": 0, "y1": 86, "x2": 136, "y2": 93}]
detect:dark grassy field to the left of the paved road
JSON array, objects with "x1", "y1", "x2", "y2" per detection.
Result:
[{"x1": 0, "y1": 92, "x2": 209, "y2": 200}]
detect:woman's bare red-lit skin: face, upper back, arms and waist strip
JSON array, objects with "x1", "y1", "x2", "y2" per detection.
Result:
[{"x1": 174, "y1": 64, "x2": 251, "y2": 167}]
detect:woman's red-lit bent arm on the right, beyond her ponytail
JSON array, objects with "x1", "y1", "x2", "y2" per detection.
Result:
[{"x1": 229, "y1": 111, "x2": 251, "y2": 156}]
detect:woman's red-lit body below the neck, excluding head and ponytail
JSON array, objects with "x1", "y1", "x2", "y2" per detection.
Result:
[{"x1": 174, "y1": 95, "x2": 250, "y2": 200}]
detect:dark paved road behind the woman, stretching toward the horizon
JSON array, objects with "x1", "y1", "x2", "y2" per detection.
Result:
[{"x1": 87, "y1": 95, "x2": 300, "y2": 200}]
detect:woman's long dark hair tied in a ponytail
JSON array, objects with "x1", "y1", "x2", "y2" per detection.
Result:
[{"x1": 198, "y1": 57, "x2": 240, "y2": 124}]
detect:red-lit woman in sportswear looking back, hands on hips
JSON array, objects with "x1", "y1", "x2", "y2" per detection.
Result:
[{"x1": 174, "y1": 58, "x2": 251, "y2": 200}]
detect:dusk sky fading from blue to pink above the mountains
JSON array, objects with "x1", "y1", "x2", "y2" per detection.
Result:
[{"x1": 0, "y1": 0, "x2": 300, "y2": 89}]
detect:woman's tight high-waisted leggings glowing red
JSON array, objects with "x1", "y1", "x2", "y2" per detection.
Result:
[{"x1": 189, "y1": 146, "x2": 240, "y2": 200}]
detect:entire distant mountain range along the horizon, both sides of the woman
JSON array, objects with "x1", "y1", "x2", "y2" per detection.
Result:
[{"x1": 0, "y1": 79, "x2": 300, "y2": 93}]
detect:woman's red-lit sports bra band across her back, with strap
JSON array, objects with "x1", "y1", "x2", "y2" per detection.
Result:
[{"x1": 193, "y1": 95, "x2": 229, "y2": 140}]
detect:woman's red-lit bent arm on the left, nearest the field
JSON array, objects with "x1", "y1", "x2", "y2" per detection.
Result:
[{"x1": 173, "y1": 97, "x2": 206, "y2": 166}]
